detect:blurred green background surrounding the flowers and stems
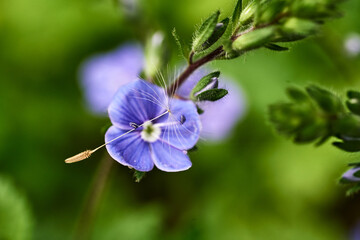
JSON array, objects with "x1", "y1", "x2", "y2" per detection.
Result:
[{"x1": 0, "y1": 0, "x2": 360, "y2": 240}]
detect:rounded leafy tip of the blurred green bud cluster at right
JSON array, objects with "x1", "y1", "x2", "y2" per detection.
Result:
[{"x1": 269, "y1": 85, "x2": 344, "y2": 145}]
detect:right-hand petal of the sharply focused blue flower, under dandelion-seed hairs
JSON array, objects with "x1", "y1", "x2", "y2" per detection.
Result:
[{"x1": 158, "y1": 99, "x2": 201, "y2": 150}]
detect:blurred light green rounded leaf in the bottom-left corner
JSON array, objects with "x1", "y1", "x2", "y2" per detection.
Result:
[{"x1": 0, "y1": 176, "x2": 33, "y2": 240}]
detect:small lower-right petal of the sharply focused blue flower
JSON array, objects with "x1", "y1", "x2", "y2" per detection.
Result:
[{"x1": 150, "y1": 141, "x2": 191, "y2": 172}]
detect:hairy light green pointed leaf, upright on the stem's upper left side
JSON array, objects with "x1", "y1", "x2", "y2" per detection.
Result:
[{"x1": 192, "y1": 11, "x2": 220, "y2": 52}]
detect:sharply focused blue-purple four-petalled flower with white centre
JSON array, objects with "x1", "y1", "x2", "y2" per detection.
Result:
[{"x1": 105, "y1": 80, "x2": 201, "y2": 172}]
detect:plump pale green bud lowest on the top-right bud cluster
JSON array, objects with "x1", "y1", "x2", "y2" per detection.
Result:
[{"x1": 232, "y1": 27, "x2": 277, "y2": 51}]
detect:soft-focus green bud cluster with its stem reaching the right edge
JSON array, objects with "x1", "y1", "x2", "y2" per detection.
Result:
[{"x1": 269, "y1": 85, "x2": 360, "y2": 152}]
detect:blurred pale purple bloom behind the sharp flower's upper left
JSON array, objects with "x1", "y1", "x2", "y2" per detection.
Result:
[{"x1": 80, "y1": 44, "x2": 144, "y2": 115}]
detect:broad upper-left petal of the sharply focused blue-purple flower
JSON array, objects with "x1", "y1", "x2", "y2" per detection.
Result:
[{"x1": 108, "y1": 80, "x2": 167, "y2": 130}]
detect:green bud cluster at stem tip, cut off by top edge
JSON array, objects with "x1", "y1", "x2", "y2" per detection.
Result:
[{"x1": 231, "y1": 0, "x2": 340, "y2": 55}]
